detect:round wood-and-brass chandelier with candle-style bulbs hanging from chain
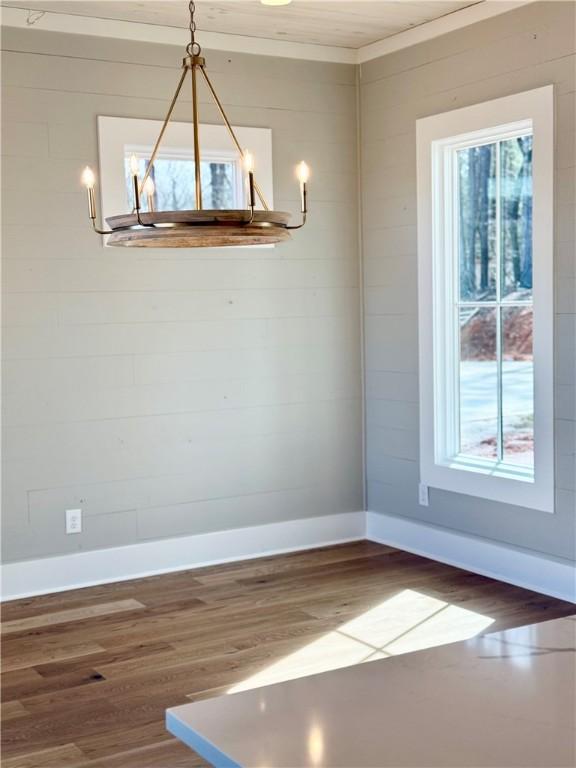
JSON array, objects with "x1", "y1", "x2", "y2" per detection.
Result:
[{"x1": 82, "y1": 2, "x2": 310, "y2": 248}]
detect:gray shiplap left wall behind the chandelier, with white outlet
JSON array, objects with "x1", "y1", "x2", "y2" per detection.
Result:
[{"x1": 2, "y1": 29, "x2": 362, "y2": 561}]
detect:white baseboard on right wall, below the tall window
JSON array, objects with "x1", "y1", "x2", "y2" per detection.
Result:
[{"x1": 366, "y1": 512, "x2": 576, "y2": 603}]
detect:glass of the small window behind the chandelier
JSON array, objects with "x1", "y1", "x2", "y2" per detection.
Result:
[{"x1": 124, "y1": 154, "x2": 237, "y2": 211}]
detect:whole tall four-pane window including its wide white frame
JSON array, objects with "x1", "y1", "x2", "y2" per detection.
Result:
[{"x1": 417, "y1": 86, "x2": 554, "y2": 511}]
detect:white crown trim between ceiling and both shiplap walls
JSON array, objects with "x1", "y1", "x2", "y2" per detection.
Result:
[{"x1": 0, "y1": 0, "x2": 535, "y2": 64}]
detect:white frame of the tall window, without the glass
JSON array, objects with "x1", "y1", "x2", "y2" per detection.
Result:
[{"x1": 416, "y1": 85, "x2": 554, "y2": 512}]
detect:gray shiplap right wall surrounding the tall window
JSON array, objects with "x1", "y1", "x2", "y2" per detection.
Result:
[{"x1": 361, "y1": 2, "x2": 576, "y2": 558}]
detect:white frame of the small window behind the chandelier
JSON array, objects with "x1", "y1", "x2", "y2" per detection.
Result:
[{"x1": 98, "y1": 115, "x2": 274, "y2": 248}]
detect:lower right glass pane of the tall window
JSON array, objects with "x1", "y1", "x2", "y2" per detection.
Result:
[{"x1": 502, "y1": 307, "x2": 534, "y2": 466}]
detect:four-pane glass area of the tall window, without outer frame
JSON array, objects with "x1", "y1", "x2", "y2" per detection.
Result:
[{"x1": 456, "y1": 133, "x2": 534, "y2": 470}]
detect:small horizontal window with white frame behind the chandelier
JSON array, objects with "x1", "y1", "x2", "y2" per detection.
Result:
[{"x1": 98, "y1": 117, "x2": 273, "y2": 247}]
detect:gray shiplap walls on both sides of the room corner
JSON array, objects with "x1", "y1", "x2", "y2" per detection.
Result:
[{"x1": 2, "y1": 3, "x2": 576, "y2": 560}]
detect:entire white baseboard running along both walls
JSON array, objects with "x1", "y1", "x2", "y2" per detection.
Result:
[{"x1": 1, "y1": 512, "x2": 576, "y2": 602}]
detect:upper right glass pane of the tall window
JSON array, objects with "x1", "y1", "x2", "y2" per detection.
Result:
[{"x1": 500, "y1": 136, "x2": 532, "y2": 300}]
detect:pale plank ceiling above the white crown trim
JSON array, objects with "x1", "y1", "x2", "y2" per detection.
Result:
[{"x1": 1, "y1": 0, "x2": 485, "y2": 48}]
